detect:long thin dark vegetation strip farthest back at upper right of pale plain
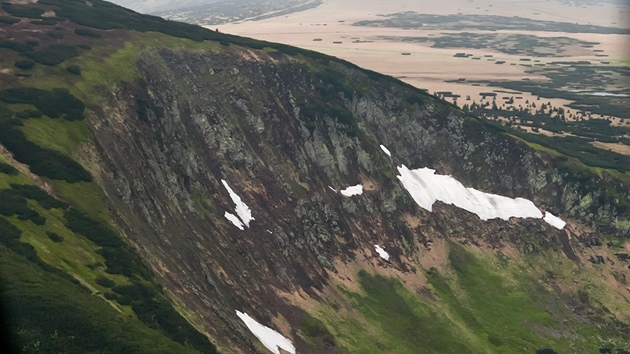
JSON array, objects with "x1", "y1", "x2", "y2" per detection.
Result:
[{"x1": 354, "y1": 12, "x2": 630, "y2": 34}]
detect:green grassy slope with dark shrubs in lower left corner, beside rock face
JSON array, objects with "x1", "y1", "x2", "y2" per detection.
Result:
[{"x1": 0, "y1": 165, "x2": 215, "y2": 353}]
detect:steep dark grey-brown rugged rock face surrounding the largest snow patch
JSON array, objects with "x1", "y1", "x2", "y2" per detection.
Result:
[{"x1": 90, "y1": 49, "x2": 630, "y2": 351}]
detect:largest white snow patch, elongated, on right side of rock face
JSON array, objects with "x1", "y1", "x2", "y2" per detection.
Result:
[{"x1": 397, "y1": 165, "x2": 543, "y2": 220}]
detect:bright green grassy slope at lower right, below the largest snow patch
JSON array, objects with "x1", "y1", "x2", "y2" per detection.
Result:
[{"x1": 302, "y1": 243, "x2": 630, "y2": 353}]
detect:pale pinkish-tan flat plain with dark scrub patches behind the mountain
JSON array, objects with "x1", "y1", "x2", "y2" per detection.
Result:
[{"x1": 221, "y1": 0, "x2": 630, "y2": 159}]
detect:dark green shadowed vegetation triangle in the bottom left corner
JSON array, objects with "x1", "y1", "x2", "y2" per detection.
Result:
[{"x1": 0, "y1": 246, "x2": 212, "y2": 353}]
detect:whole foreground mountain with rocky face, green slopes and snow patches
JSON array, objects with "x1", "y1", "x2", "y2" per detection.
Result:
[{"x1": 0, "y1": 0, "x2": 630, "y2": 353}]
